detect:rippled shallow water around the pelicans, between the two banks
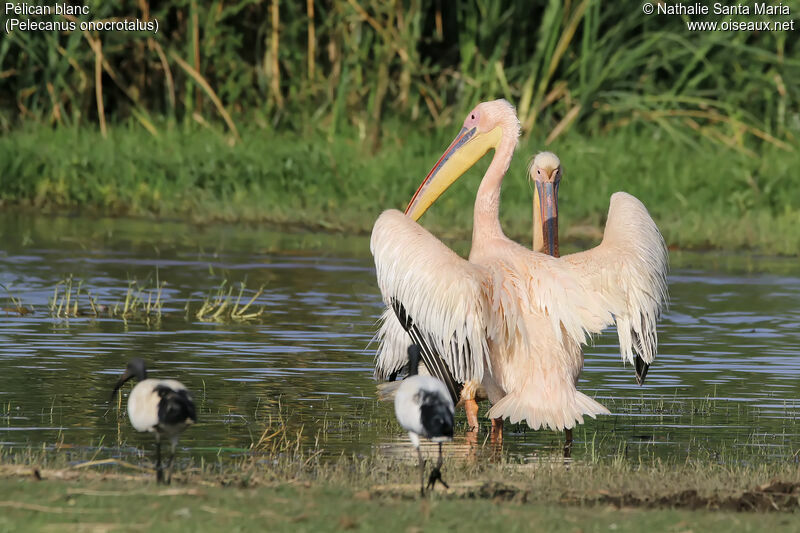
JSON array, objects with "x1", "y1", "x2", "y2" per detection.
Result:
[{"x1": 0, "y1": 210, "x2": 800, "y2": 464}]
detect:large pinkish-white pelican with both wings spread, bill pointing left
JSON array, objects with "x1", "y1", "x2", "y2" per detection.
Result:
[{"x1": 371, "y1": 100, "x2": 667, "y2": 436}]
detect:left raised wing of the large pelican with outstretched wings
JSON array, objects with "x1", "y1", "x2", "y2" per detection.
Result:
[{"x1": 370, "y1": 210, "x2": 491, "y2": 401}]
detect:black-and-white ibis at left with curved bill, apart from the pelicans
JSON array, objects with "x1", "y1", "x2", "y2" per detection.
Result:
[{"x1": 111, "y1": 358, "x2": 197, "y2": 483}]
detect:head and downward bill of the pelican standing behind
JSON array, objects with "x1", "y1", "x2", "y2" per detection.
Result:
[{"x1": 528, "y1": 152, "x2": 562, "y2": 257}]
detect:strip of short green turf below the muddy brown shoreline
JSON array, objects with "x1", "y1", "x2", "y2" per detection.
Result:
[{"x1": 0, "y1": 481, "x2": 795, "y2": 532}]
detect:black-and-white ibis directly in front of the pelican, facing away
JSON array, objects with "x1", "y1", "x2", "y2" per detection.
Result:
[{"x1": 394, "y1": 344, "x2": 455, "y2": 496}]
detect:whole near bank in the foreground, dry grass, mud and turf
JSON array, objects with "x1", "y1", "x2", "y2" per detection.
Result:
[{"x1": 0, "y1": 448, "x2": 800, "y2": 531}]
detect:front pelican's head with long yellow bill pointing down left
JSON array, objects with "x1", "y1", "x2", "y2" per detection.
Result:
[{"x1": 406, "y1": 99, "x2": 519, "y2": 220}]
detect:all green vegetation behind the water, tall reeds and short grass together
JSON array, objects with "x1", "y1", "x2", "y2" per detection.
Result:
[{"x1": 0, "y1": 0, "x2": 800, "y2": 254}]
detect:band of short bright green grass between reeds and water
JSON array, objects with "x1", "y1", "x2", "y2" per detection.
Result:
[{"x1": 0, "y1": 125, "x2": 800, "y2": 255}]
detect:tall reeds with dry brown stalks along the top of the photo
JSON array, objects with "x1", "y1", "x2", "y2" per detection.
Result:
[{"x1": 0, "y1": 0, "x2": 800, "y2": 150}]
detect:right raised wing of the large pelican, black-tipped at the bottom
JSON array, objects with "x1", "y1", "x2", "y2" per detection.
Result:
[{"x1": 562, "y1": 192, "x2": 668, "y2": 385}]
